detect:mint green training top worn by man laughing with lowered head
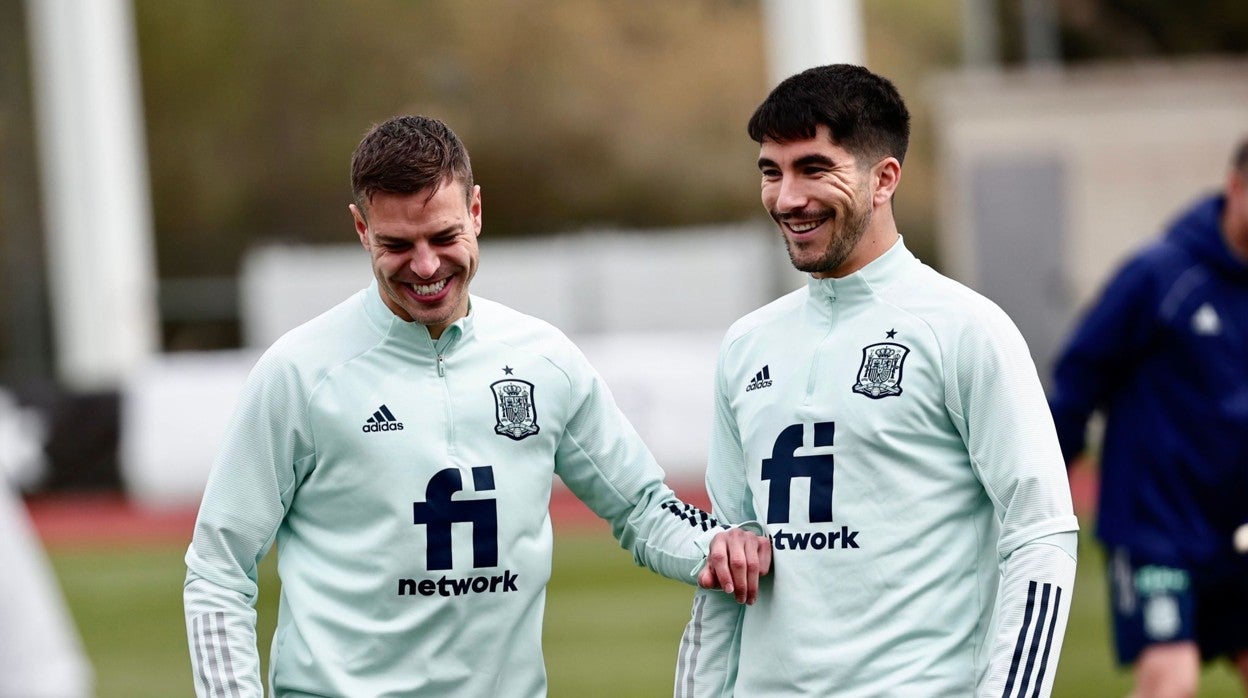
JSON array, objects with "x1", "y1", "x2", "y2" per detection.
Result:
[{"x1": 185, "y1": 283, "x2": 719, "y2": 698}]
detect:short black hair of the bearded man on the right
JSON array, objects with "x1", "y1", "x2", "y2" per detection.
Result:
[{"x1": 748, "y1": 64, "x2": 910, "y2": 162}]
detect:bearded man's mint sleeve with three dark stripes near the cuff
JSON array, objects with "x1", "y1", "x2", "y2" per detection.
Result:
[{"x1": 947, "y1": 302, "x2": 1078, "y2": 697}]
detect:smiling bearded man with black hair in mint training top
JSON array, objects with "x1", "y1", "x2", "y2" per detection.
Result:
[{"x1": 675, "y1": 65, "x2": 1078, "y2": 698}]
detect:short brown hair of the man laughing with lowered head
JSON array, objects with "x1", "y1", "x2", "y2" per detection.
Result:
[{"x1": 351, "y1": 116, "x2": 473, "y2": 215}]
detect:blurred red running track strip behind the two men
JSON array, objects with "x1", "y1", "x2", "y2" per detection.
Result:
[{"x1": 26, "y1": 468, "x2": 1096, "y2": 548}]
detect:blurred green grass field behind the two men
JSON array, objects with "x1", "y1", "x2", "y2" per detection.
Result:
[{"x1": 43, "y1": 529, "x2": 1242, "y2": 698}]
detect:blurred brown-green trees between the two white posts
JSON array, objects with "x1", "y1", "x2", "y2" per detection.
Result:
[{"x1": 135, "y1": 0, "x2": 764, "y2": 277}]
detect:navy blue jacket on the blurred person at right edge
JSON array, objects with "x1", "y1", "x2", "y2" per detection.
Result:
[{"x1": 1050, "y1": 196, "x2": 1248, "y2": 564}]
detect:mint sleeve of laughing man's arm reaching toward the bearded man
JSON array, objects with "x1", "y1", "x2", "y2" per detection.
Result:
[{"x1": 555, "y1": 349, "x2": 726, "y2": 584}]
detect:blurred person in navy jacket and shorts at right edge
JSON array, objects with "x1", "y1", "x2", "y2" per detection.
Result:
[{"x1": 1050, "y1": 139, "x2": 1248, "y2": 698}]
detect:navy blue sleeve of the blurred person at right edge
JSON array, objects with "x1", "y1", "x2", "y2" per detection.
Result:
[{"x1": 1048, "y1": 258, "x2": 1156, "y2": 463}]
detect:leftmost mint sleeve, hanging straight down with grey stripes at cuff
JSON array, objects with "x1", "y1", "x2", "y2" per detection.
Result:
[{"x1": 183, "y1": 360, "x2": 308, "y2": 698}]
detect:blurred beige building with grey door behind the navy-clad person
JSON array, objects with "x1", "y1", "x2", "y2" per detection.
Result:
[{"x1": 931, "y1": 61, "x2": 1248, "y2": 380}]
